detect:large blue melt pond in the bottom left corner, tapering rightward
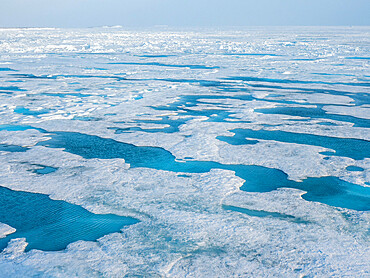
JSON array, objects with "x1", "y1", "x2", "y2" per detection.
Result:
[{"x1": 0, "y1": 187, "x2": 139, "y2": 251}]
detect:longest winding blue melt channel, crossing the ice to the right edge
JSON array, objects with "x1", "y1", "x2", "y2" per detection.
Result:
[{"x1": 38, "y1": 132, "x2": 370, "y2": 210}]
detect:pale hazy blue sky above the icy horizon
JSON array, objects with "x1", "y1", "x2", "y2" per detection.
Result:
[{"x1": 0, "y1": 0, "x2": 370, "y2": 27}]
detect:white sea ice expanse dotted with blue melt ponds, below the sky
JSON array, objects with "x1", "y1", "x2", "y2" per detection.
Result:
[{"x1": 0, "y1": 27, "x2": 370, "y2": 277}]
